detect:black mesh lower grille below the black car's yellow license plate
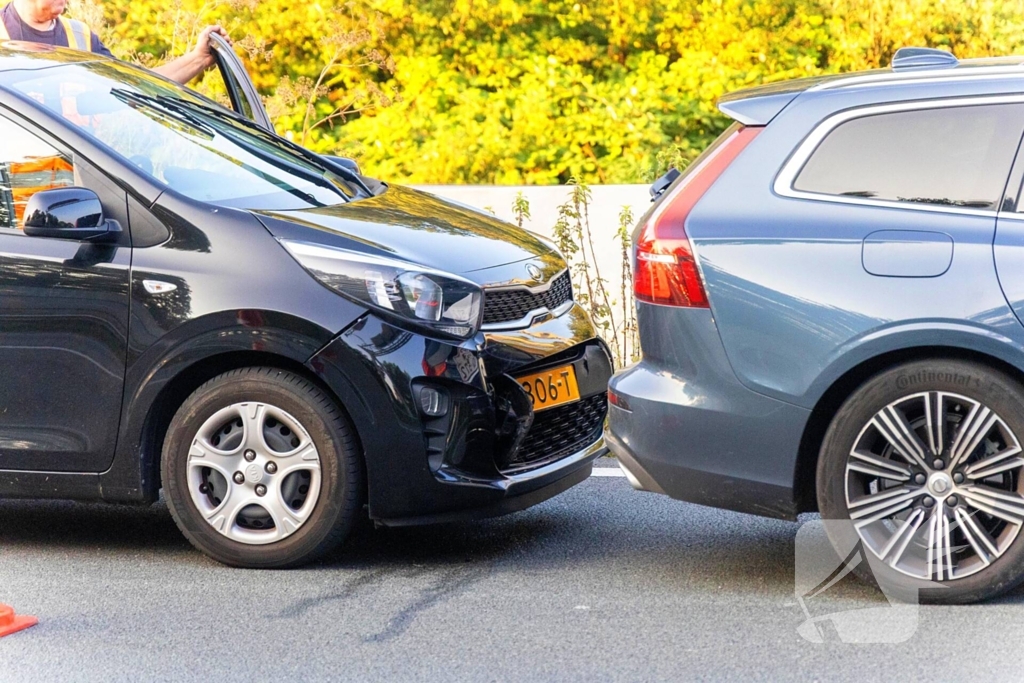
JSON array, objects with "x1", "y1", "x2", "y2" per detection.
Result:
[{"x1": 503, "y1": 393, "x2": 608, "y2": 474}]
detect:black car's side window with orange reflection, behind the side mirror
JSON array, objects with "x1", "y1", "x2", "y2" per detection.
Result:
[{"x1": 0, "y1": 117, "x2": 75, "y2": 229}]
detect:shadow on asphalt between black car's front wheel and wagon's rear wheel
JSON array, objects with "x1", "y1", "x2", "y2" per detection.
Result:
[{"x1": 310, "y1": 482, "x2": 811, "y2": 596}]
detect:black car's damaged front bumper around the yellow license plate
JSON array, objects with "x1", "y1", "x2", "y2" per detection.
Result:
[{"x1": 308, "y1": 306, "x2": 611, "y2": 525}]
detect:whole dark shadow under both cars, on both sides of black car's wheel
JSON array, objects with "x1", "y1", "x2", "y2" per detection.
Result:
[{"x1": 0, "y1": 481, "x2": 811, "y2": 594}]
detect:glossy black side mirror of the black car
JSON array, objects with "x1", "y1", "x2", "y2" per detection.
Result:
[{"x1": 25, "y1": 187, "x2": 121, "y2": 242}]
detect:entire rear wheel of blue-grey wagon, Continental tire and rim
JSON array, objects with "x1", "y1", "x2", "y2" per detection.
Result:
[{"x1": 817, "y1": 359, "x2": 1024, "y2": 603}]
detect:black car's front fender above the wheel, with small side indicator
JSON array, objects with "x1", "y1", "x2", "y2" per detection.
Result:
[{"x1": 99, "y1": 191, "x2": 365, "y2": 502}]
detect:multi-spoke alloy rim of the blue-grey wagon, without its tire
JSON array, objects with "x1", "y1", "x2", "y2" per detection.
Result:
[{"x1": 846, "y1": 391, "x2": 1024, "y2": 581}]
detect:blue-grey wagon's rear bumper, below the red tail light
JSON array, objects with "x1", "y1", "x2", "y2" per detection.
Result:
[{"x1": 607, "y1": 304, "x2": 810, "y2": 518}]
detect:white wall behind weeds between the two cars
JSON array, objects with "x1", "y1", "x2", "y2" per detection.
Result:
[{"x1": 409, "y1": 185, "x2": 650, "y2": 295}]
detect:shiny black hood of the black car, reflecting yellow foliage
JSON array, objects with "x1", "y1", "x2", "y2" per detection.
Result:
[{"x1": 255, "y1": 185, "x2": 565, "y2": 286}]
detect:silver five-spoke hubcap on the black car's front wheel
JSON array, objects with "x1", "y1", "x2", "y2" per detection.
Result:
[{"x1": 188, "y1": 402, "x2": 321, "y2": 545}]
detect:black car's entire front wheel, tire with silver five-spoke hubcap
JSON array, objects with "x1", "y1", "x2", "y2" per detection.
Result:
[{"x1": 161, "y1": 368, "x2": 364, "y2": 568}]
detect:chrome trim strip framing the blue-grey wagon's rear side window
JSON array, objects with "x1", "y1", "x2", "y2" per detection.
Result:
[{"x1": 772, "y1": 95, "x2": 1024, "y2": 218}]
